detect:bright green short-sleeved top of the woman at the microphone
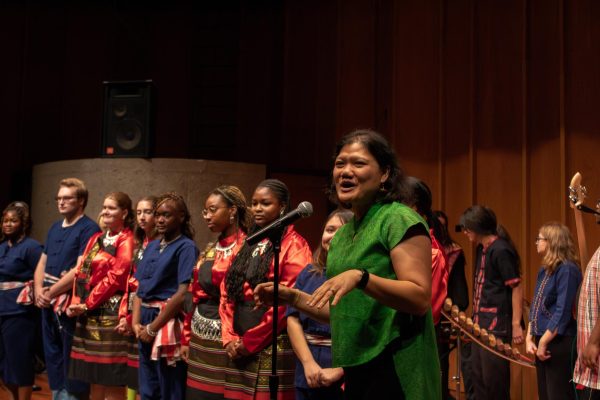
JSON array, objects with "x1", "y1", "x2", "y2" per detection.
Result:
[{"x1": 327, "y1": 203, "x2": 441, "y2": 399}]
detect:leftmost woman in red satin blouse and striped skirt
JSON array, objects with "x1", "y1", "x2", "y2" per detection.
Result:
[{"x1": 49, "y1": 192, "x2": 134, "y2": 399}]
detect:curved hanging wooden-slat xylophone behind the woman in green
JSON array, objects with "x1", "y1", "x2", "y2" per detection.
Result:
[{"x1": 442, "y1": 298, "x2": 535, "y2": 368}]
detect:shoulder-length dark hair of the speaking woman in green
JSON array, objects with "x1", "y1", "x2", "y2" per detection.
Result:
[{"x1": 328, "y1": 129, "x2": 404, "y2": 208}]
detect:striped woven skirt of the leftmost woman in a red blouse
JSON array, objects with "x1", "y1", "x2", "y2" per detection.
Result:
[{"x1": 69, "y1": 308, "x2": 129, "y2": 386}]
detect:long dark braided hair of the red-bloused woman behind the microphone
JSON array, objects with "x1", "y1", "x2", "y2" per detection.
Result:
[{"x1": 225, "y1": 179, "x2": 290, "y2": 302}]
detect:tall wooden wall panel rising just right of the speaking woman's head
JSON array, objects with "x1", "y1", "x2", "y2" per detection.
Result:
[{"x1": 391, "y1": 1, "x2": 441, "y2": 190}]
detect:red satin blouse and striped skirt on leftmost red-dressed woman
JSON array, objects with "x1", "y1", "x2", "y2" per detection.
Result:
[{"x1": 69, "y1": 229, "x2": 133, "y2": 386}]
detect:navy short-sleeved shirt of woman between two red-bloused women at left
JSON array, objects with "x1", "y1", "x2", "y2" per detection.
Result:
[{"x1": 135, "y1": 236, "x2": 198, "y2": 301}]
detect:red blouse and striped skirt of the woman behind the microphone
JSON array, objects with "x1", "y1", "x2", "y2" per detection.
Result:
[{"x1": 219, "y1": 226, "x2": 312, "y2": 400}]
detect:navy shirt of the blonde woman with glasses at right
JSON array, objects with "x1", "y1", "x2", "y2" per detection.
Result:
[{"x1": 529, "y1": 261, "x2": 583, "y2": 336}]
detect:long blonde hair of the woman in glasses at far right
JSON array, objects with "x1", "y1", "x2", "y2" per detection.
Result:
[{"x1": 540, "y1": 221, "x2": 579, "y2": 274}]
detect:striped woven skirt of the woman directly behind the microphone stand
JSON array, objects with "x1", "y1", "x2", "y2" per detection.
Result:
[{"x1": 224, "y1": 334, "x2": 296, "y2": 400}]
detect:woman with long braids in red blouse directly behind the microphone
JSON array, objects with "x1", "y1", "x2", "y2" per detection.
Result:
[{"x1": 219, "y1": 179, "x2": 312, "y2": 400}]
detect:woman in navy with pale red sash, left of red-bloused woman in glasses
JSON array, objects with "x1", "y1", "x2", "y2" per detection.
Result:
[{"x1": 132, "y1": 193, "x2": 198, "y2": 400}]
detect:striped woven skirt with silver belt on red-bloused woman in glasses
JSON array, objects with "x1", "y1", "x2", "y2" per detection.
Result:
[{"x1": 186, "y1": 309, "x2": 229, "y2": 400}]
